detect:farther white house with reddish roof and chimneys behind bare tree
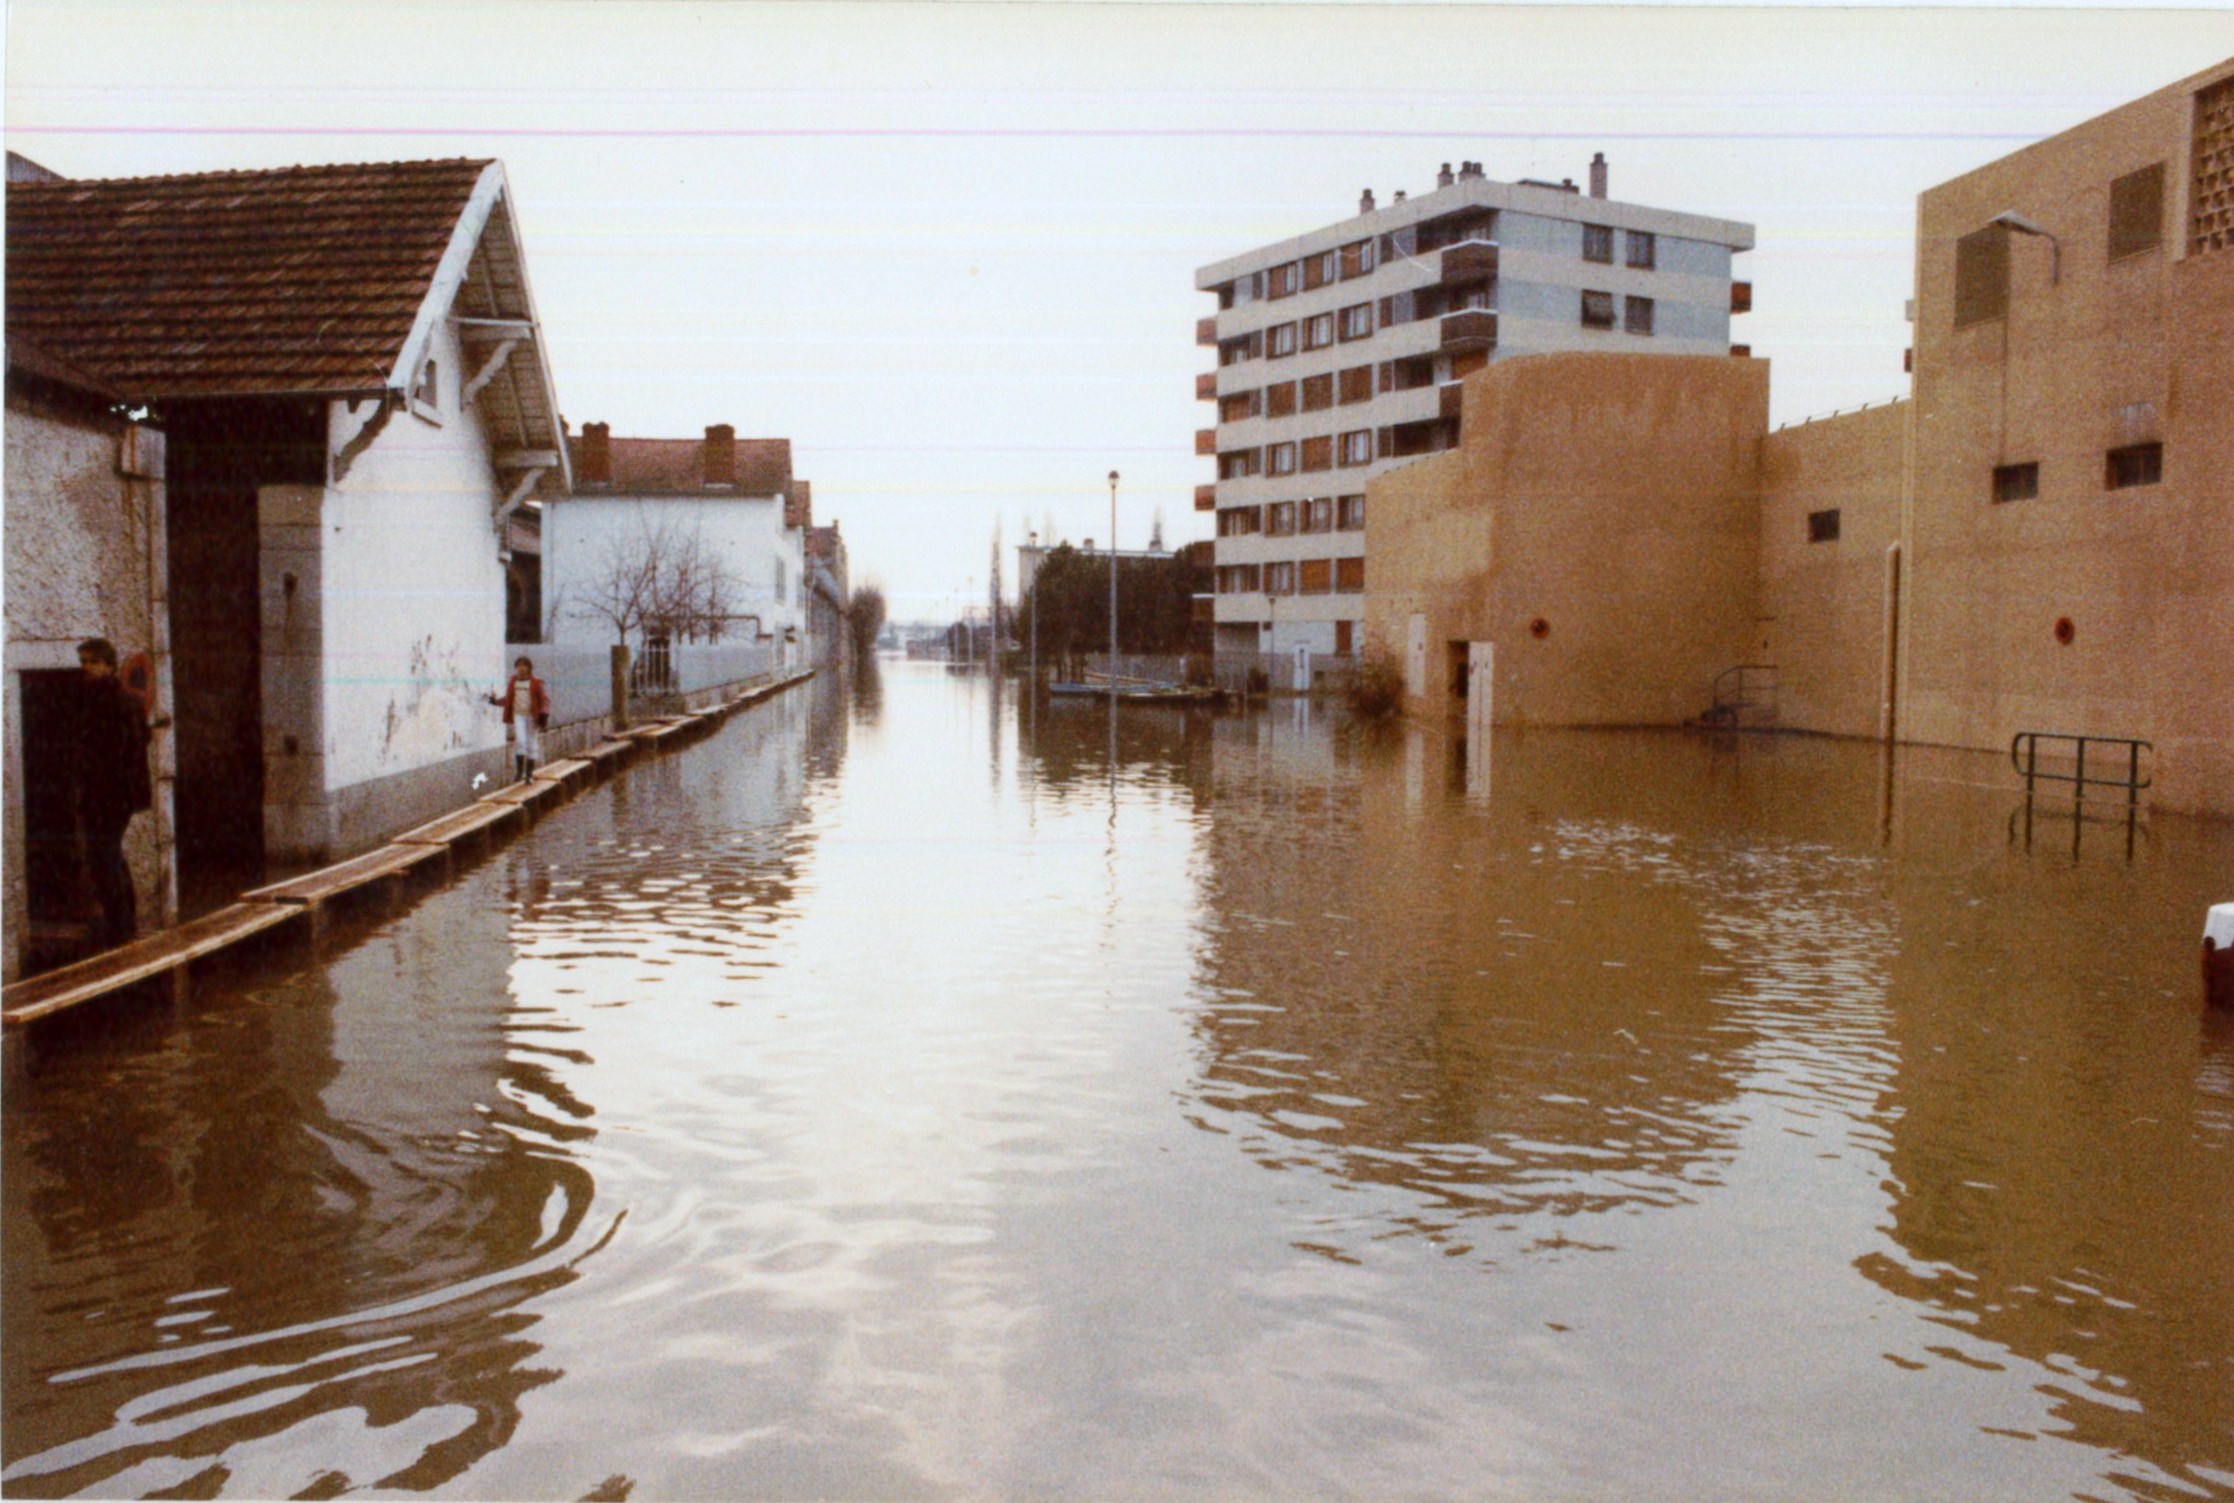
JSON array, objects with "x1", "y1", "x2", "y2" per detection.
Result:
[{"x1": 543, "y1": 422, "x2": 811, "y2": 670}]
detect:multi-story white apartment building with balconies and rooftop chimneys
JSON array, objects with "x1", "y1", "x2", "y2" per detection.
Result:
[{"x1": 1195, "y1": 154, "x2": 1754, "y2": 654}]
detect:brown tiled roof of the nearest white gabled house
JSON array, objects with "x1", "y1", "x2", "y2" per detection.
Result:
[{"x1": 7, "y1": 161, "x2": 489, "y2": 400}]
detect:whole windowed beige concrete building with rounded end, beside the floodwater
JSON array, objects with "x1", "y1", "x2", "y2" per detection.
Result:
[{"x1": 1365, "y1": 60, "x2": 2234, "y2": 815}]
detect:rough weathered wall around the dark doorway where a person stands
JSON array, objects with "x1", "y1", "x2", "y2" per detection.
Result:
[{"x1": 0, "y1": 380, "x2": 176, "y2": 980}]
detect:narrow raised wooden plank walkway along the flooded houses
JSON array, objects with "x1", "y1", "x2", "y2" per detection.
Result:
[{"x1": 0, "y1": 670, "x2": 813, "y2": 1027}]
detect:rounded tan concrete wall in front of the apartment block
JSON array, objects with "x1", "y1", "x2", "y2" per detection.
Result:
[{"x1": 1365, "y1": 355, "x2": 1767, "y2": 726}]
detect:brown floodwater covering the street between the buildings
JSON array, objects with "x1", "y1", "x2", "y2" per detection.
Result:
[{"x1": 0, "y1": 666, "x2": 2234, "y2": 1499}]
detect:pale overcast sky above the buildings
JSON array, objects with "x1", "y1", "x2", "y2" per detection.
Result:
[{"x1": 7, "y1": 0, "x2": 2234, "y2": 619}]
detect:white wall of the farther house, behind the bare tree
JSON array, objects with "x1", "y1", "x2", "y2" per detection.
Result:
[{"x1": 543, "y1": 494, "x2": 806, "y2": 670}]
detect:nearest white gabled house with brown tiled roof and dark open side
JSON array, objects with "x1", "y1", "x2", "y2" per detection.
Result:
[{"x1": 7, "y1": 161, "x2": 567, "y2": 897}]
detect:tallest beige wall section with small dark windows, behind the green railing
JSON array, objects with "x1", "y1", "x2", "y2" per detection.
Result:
[{"x1": 1901, "y1": 63, "x2": 2234, "y2": 813}]
